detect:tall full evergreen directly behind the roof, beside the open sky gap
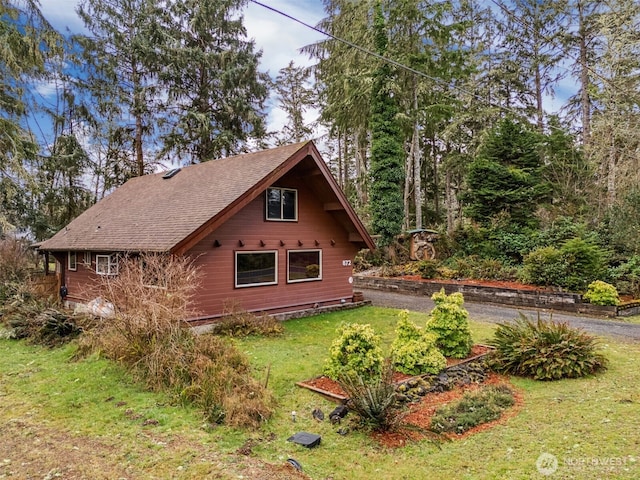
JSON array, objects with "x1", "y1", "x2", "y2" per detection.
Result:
[{"x1": 162, "y1": 0, "x2": 269, "y2": 163}]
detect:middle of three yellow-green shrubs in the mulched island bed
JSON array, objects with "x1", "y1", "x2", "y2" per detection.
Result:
[{"x1": 391, "y1": 310, "x2": 447, "y2": 375}]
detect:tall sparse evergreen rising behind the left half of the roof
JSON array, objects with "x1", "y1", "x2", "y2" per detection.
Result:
[{"x1": 75, "y1": 0, "x2": 167, "y2": 181}]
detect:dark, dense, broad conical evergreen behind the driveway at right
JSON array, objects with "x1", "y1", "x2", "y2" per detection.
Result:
[{"x1": 464, "y1": 119, "x2": 548, "y2": 226}]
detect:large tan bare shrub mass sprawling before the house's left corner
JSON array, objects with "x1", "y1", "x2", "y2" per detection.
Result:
[{"x1": 81, "y1": 254, "x2": 272, "y2": 427}]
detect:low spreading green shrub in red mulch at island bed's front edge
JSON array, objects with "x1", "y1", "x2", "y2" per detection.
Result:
[{"x1": 430, "y1": 385, "x2": 515, "y2": 434}]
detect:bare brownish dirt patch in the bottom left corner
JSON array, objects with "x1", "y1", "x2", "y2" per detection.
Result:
[{"x1": 0, "y1": 416, "x2": 309, "y2": 480}]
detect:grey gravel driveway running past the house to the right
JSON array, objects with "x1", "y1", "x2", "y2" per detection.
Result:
[{"x1": 359, "y1": 288, "x2": 640, "y2": 341}]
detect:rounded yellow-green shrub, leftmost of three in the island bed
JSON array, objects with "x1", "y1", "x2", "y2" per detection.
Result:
[{"x1": 324, "y1": 323, "x2": 384, "y2": 381}]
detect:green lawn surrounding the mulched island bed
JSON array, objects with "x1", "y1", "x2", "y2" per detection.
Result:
[{"x1": 0, "y1": 307, "x2": 640, "y2": 480}]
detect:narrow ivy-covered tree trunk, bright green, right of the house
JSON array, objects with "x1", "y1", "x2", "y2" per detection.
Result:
[{"x1": 370, "y1": 1, "x2": 404, "y2": 246}]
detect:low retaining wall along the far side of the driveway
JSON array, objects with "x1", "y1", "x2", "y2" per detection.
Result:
[{"x1": 354, "y1": 275, "x2": 640, "y2": 317}]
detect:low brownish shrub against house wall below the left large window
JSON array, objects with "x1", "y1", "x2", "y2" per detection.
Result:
[{"x1": 213, "y1": 300, "x2": 284, "y2": 337}]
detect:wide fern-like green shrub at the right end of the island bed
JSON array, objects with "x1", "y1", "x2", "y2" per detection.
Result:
[{"x1": 489, "y1": 314, "x2": 607, "y2": 380}]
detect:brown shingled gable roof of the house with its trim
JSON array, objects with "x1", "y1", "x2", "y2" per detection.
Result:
[{"x1": 38, "y1": 142, "x2": 373, "y2": 253}]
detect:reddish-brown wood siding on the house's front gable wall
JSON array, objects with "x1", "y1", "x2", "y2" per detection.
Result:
[{"x1": 189, "y1": 175, "x2": 357, "y2": 317}]
